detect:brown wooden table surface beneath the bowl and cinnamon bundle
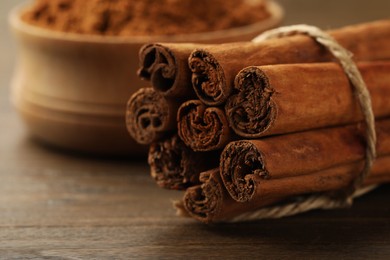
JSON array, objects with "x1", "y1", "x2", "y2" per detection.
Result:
[{"x1": 0, "y1": 0, "x2": 390, "y2": 259}]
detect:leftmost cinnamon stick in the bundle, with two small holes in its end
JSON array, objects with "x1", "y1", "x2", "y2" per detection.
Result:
[{"x1": 126, "y1": 88, "x2": 179, "y2": 144}]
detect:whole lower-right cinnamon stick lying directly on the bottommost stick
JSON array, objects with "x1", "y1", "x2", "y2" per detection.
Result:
[{"x1": 220, "y1": 120, "x2": 390, "y2": 202}]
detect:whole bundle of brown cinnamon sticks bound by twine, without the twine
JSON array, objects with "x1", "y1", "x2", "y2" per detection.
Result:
[{"x1": 126, "y1": 20, "x2": 390, "y2": 223}]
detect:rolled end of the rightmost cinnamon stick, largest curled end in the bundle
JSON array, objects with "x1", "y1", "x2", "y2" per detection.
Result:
[{"x1": 225, "y1": 67, "x2": 277, "y2": 138}]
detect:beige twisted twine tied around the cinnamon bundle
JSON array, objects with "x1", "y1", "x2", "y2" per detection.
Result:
[{"x1": 227, "y1": 24, "x2": 376, "y2": 222}]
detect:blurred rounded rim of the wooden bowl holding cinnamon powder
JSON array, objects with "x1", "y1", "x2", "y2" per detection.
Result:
[{"x1": 8, "y1": 0, "x2": 284, "y2": 44}]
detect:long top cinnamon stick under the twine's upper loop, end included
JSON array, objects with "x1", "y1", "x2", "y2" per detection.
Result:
[{"x1": 189, "y1": 20, "x2": 390, "y2": 105}]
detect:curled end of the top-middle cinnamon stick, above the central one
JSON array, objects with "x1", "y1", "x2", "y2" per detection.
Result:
[{"x1": 188, "y1": 50, "x2": 231, "y2": 106}]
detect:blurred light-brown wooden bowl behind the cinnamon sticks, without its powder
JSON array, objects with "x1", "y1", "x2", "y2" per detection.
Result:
[{"x1": 9, "y1": 2, "x2": 283, "y2": 156}]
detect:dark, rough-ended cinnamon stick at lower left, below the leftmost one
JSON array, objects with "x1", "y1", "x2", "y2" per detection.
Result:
[{"x1": 148, "y1": 135, "x2": 219, "y2": 190}]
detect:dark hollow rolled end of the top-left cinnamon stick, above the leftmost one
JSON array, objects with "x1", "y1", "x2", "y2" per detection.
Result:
[{"x1": 138, "y1": 44, "x2": 177, "y2": 94}]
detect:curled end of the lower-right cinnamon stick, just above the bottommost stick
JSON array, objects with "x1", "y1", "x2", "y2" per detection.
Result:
[{"x1": 220, "y1": 141, "x2": 268, "y2": 202}]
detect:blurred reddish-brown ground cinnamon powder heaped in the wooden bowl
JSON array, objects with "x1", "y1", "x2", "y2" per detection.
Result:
[{"x1": 23, "y1": 0, "x2": 269, "y2": 36}]
